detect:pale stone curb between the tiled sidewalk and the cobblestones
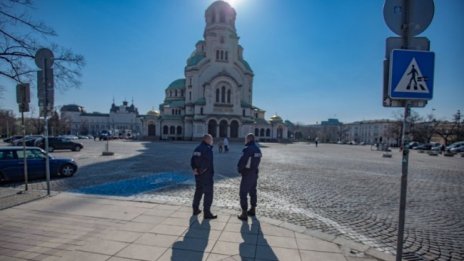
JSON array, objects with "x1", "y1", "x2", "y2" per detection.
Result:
[{"x1": 60, "y1": 192, "x2": 395, "y2": 261}]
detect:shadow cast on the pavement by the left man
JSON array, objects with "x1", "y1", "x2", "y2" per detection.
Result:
[{"x1": 171, "y1": 216, "x2": 211, "y2": 261}]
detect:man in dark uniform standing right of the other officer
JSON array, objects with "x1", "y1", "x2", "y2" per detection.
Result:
[{"x1": 237, "y1": 133, "x2": 262, "y2": 220}]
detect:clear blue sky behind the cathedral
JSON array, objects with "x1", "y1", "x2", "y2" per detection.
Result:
[{"x1": 0, "y1": 0, "x2": 464, "y2": 124}]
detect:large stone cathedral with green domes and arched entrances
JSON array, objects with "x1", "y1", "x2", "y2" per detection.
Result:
[{"x1": 143, "y1": 1, "x2": 288, "y2": 140}]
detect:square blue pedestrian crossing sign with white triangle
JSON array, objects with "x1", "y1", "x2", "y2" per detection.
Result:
[{"x1": 389, "y1": 49, "x2": 435, "y2": 100}]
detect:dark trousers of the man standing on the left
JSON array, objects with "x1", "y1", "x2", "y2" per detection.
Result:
[{"x1": 192, "y1": 173, "x2": 214, "y2": 214}]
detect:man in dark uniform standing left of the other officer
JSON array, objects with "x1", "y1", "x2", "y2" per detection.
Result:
[{"x1": 190, "y1": 134, "x2": 217, "y2": 219}]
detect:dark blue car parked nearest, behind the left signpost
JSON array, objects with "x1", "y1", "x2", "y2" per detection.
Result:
[{"x1": 0, "y1": 147, "x2": 77, "y2": 181}]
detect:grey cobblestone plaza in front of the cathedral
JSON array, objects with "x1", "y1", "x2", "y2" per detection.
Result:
[{"x1": 1, "y1": 141, "x2": 464, "y2": 260}]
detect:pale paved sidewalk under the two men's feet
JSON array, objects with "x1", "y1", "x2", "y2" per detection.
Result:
[{"x1": 0, "y1": 193, "x2": 394, "y2": 261}]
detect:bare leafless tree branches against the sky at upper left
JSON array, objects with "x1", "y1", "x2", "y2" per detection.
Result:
[{"x1": 0, "y1": 0, "x2": 85, "y2": 93}]
